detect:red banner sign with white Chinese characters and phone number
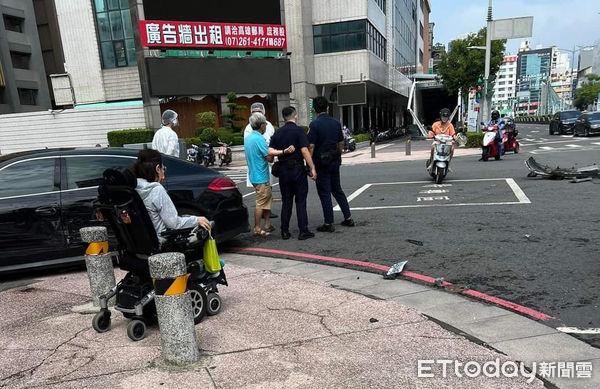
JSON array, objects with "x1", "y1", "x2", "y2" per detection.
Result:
[{"x1": 139, "y1": 20, "x2": 287, "y2": 50}]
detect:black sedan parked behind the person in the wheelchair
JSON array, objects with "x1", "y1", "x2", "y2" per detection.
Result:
[{"x1": 0, "y1": 148, "x2": 249, "y2": 272}]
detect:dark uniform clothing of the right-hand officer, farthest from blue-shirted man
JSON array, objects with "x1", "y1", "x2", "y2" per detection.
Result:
[{"x1": 308, "y1": 113, "x2": 351, "y2": 224}]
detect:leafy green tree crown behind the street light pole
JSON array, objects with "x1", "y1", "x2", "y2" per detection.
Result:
[{"x1": 437, "y1": 28, "x2": 506, "y2": 97}]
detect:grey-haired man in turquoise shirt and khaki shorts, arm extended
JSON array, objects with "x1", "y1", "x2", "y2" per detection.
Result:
[{"x1": 244, "y1": 112, "x2": 293, "y2": 236}]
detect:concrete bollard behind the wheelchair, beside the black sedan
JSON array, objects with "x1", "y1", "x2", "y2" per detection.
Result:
[{"x1": 79, "y1": 227, "x2": 116, "y2": 307}]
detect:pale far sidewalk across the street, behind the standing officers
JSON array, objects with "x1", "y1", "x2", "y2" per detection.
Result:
[{"x1": 229, "y1": 138, "x2": 481, "y2": 169}]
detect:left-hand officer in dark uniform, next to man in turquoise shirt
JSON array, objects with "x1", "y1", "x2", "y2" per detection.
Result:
[{"x1": 269, "y1": 107, "x2": 317, "y2": 240}]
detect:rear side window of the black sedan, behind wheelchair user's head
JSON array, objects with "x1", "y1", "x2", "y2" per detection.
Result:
[{"x1": 65, "y1": 156, "x2": 135, "y2": 189}]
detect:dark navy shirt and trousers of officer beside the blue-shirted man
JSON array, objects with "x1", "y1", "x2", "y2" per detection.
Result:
[{"x1": 269, "y1": 122, "x2": 309, "y2": 234}]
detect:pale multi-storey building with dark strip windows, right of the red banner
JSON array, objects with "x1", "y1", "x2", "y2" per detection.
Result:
[{"x1": 285, "y1": 0, "x2": 418, "y2": 130}]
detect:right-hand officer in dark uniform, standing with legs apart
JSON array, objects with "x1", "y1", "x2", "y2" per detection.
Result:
[{"x1": 308, "y1": 96, "x2": 354, "y2": 232}]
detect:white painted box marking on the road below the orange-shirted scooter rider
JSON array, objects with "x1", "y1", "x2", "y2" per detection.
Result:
[{"x1": 333, "y1": 178, "x2": 531, "y2": 211}]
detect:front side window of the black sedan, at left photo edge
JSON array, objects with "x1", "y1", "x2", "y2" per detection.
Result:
[{"x1": 0, "y1": 158, "x2": 57, "y2": 197}]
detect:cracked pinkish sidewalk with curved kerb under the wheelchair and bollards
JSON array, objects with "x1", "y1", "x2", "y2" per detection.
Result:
[{"x1": 0, "y1": 254, "x2": 600, "y2": 388}]
